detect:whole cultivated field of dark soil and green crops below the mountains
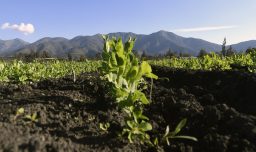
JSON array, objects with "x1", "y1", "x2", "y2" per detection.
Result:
[{"x1": 0, "y1": 40, "x2": 256, "y2": 152}]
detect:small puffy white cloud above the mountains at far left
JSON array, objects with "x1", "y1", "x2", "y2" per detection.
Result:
[{"x1": 1, "y1": 23, "x2": 35, "y2": 35}]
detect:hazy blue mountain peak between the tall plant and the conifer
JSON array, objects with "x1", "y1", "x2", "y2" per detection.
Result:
[{"x1": 136, "y1": 31, "x2": 220, "y2": 55}]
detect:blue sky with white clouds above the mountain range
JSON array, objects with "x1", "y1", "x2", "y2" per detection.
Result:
[{"x1": 0, "y1": 0, "x2": 256, "y2": 44}]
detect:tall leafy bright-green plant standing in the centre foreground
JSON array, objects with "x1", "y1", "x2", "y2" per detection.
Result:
[{"x1": 100, "y1": 36, "x2": 158, "y2": 143}]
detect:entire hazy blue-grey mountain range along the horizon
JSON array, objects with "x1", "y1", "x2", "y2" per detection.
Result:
[{"x1": 0, "y1": 31, "x2": 256, "y2": 57}]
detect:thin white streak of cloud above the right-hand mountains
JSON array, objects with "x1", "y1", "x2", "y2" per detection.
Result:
[{"x1": 175, "y1": 25, "x2": 237, "y2": 32}]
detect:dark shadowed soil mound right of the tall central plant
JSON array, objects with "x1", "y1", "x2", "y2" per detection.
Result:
[{"x1": 153, "y1": 67, "x2": 256, "y2": 151}]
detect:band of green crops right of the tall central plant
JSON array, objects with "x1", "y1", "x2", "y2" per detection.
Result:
[{"x1": 148, "y1": 51, "x2": 256, "y2": 72}]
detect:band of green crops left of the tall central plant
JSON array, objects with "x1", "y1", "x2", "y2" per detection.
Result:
[{"x1": 0, "y1": 60, "x2": 100, "y2": 83}]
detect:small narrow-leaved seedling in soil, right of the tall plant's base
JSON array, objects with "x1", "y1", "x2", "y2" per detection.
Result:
[{"x1": 163, "y1": 119, "x2": 198, "y2": 146}]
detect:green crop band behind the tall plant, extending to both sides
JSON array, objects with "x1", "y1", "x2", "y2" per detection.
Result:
[{"x1": 0, "y1": 52, "x2": 256, "y2": 83}]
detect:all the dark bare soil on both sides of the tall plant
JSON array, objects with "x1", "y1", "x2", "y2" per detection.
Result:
[{"x1": 0, "y1": 67, "x2": 256, "y2": 152}]
